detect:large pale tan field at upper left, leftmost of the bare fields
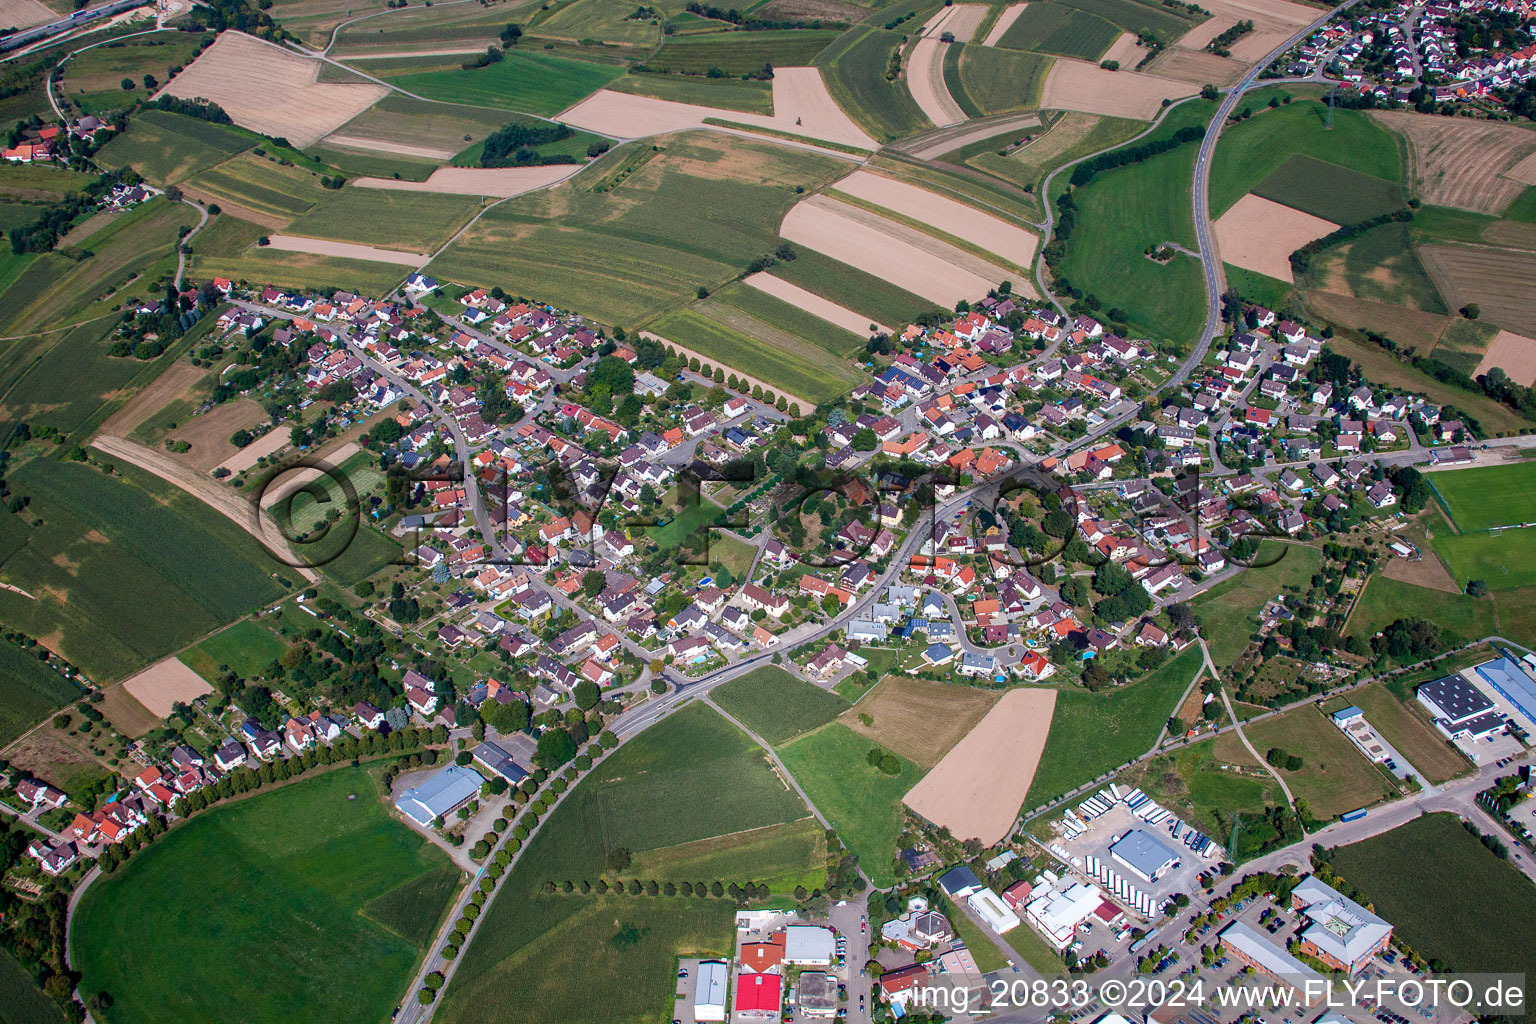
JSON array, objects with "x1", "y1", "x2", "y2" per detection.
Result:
[{"x1": 155, "y1": 32, "x2": 389, "y2": 149}]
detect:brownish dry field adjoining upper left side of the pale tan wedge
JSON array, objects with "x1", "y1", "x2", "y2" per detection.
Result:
[{"x1": 842, "y1": 676, "x2": 998, "y2": 768}]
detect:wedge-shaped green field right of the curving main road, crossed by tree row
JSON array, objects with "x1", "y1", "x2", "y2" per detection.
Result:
[{"x1": 438, "y1": 703, "x2": 811, "y2": 1024}]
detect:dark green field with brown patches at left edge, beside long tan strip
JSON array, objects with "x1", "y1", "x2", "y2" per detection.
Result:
[{"x1": 0, "y1": 461, "x2": 287, "y2": 683}]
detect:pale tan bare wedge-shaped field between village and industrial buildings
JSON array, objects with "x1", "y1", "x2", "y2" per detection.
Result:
[{"x1": 905, "y1": 689, "x2": 1055, "y2": 846}]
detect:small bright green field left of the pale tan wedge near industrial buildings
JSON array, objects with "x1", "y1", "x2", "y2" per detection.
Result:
[{"x1": 779, "y1": 722, "x2": 923, "y2": 886}]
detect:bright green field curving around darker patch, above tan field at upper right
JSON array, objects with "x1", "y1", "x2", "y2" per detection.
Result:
[{"x1": 1210, "y1": 98, "x2": 1402, "y2": 220}]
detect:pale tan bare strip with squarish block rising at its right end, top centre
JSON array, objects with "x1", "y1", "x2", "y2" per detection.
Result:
[{"x1": 561, "y1": 68, "x2": 876, "y2": 149}]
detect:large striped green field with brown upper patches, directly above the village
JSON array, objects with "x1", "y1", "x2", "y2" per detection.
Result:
[{"x1": 429, "y1": 132, "x2": 843, "y2": 325}]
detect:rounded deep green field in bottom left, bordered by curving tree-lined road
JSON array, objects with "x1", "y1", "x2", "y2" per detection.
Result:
[{"x1": 72, "y1": 769, "x2": 458, "y2": 1024}]
